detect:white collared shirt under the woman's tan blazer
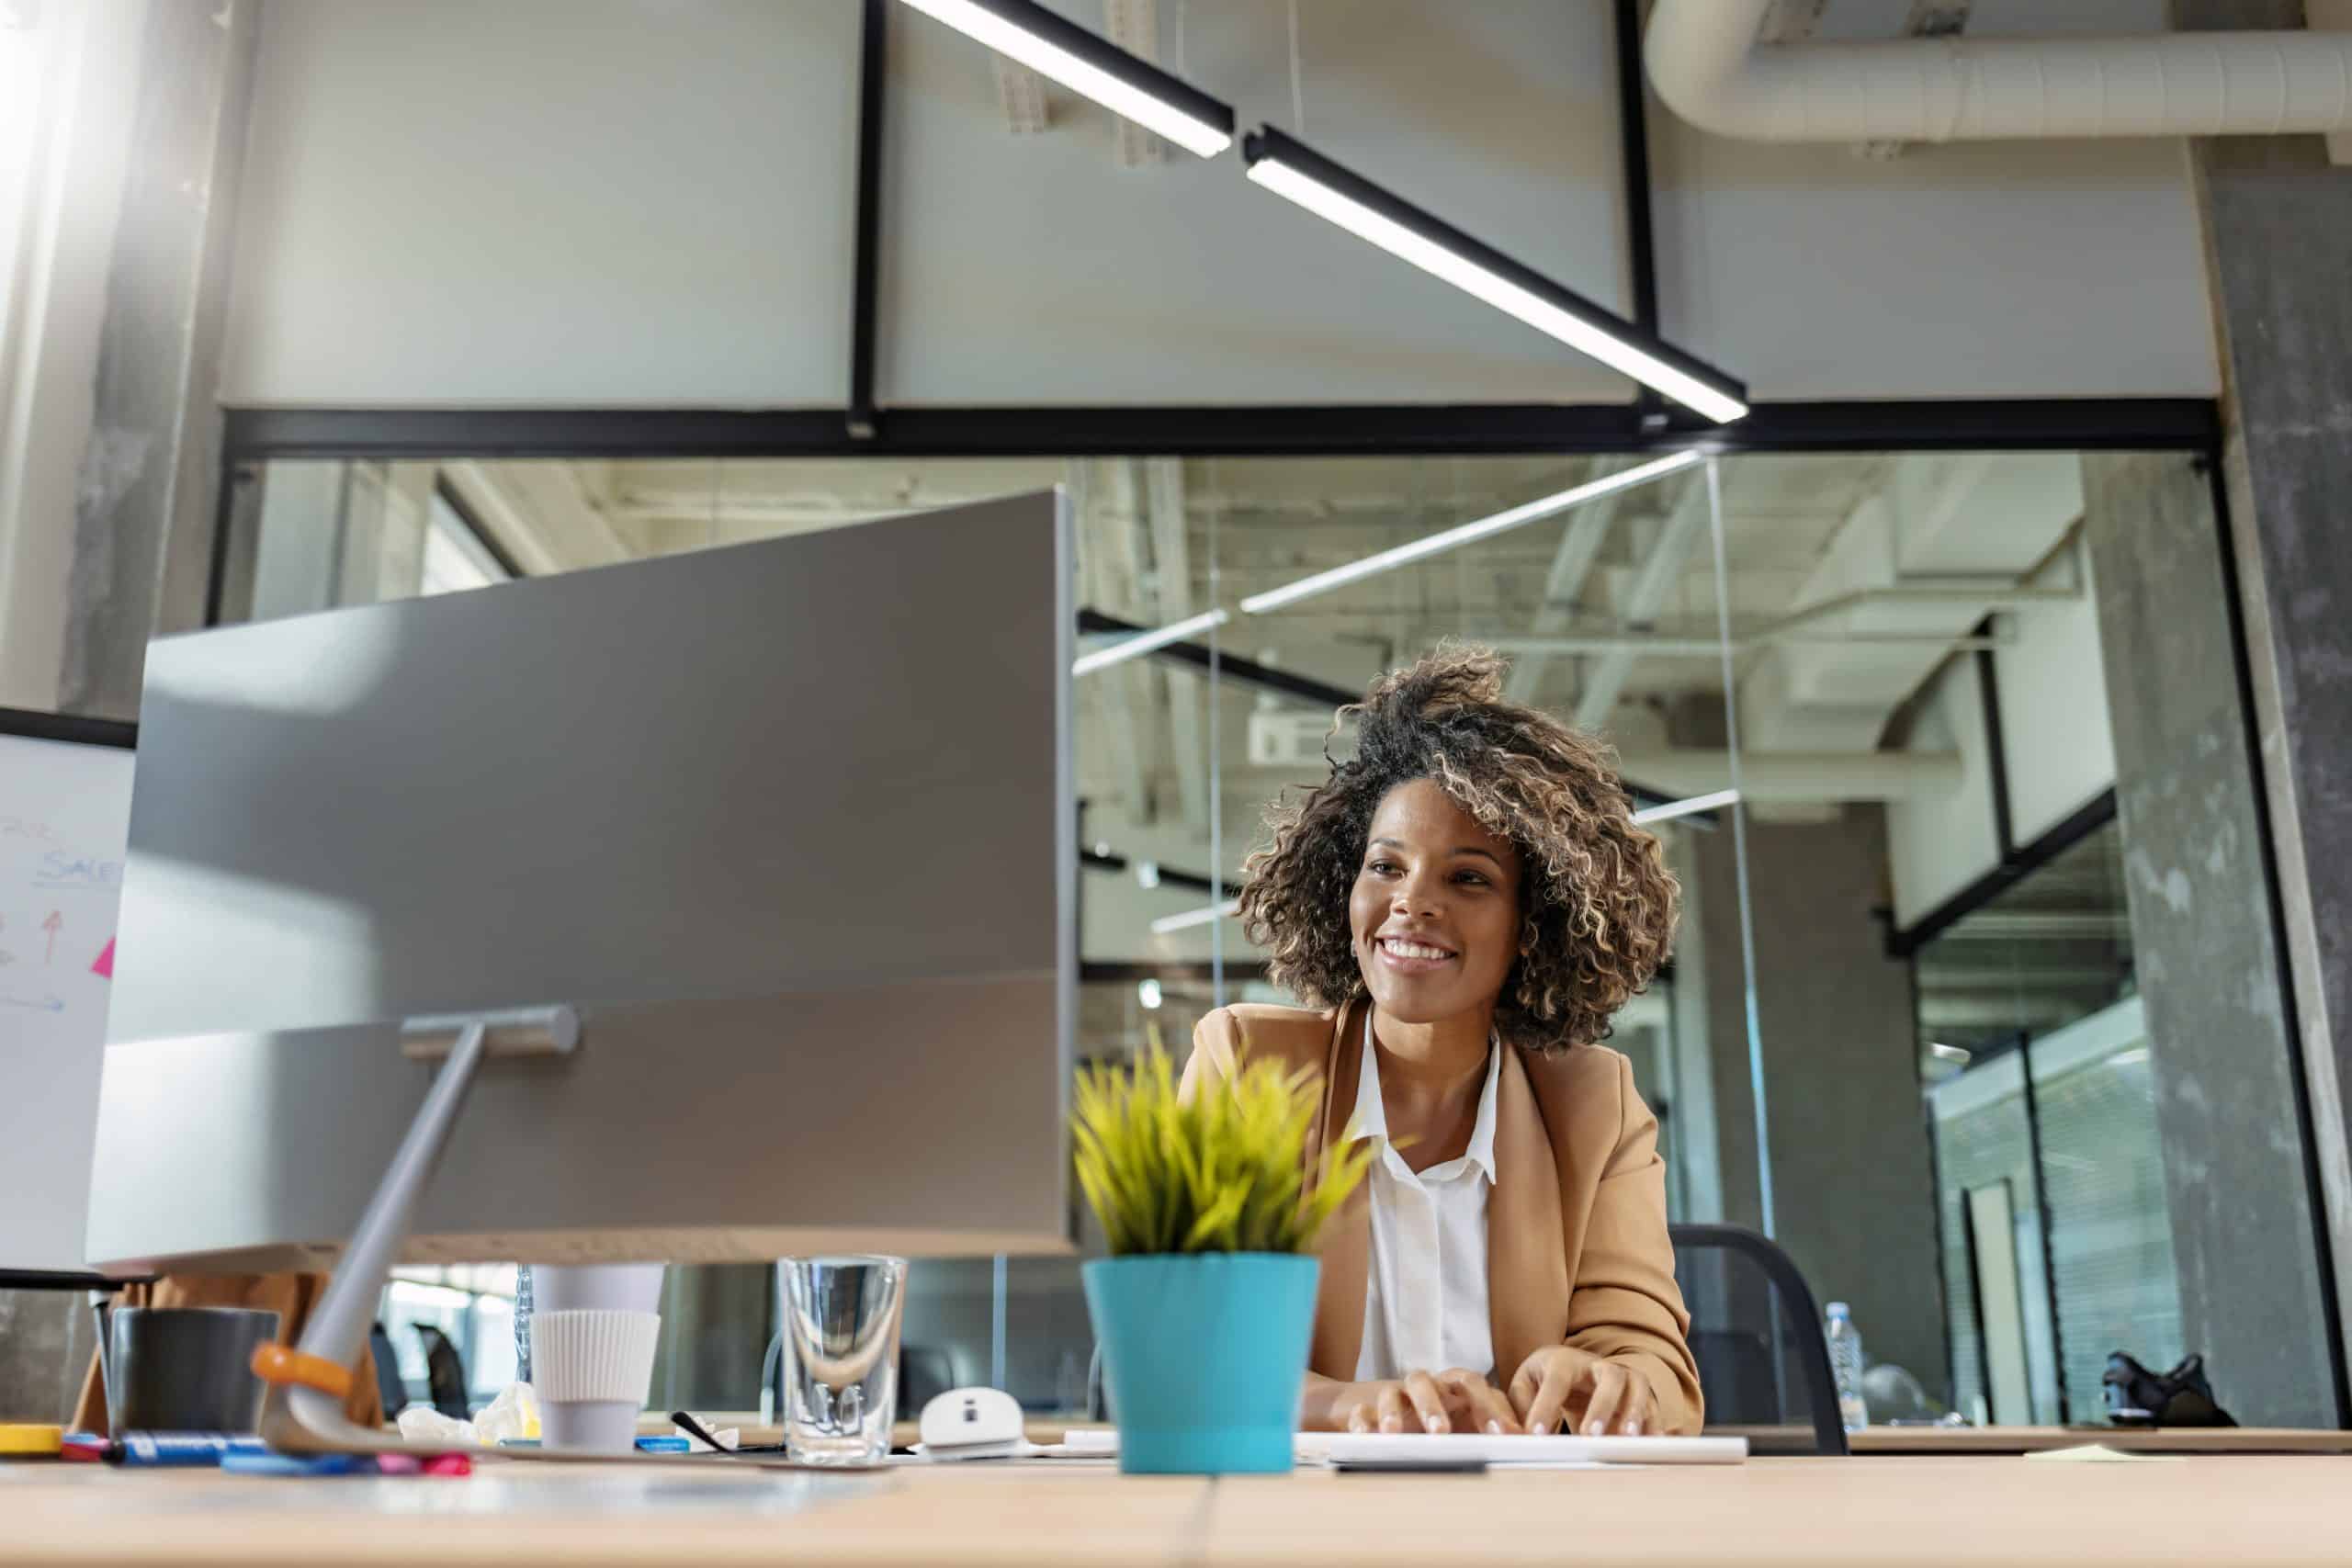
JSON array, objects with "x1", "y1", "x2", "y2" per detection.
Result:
[{"x1": 1355, "y1": 1009, "x2": 1503, "y2": 1382}]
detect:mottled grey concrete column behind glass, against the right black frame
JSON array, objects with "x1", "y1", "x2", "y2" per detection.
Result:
[{"x1": 2082, "y1": 454, "x2": 2335, "y2": 1427}]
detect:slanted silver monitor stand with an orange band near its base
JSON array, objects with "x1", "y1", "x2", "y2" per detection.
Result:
[{"x1": 254, "y1": 1006, "x2": 581, "y2": 1455}]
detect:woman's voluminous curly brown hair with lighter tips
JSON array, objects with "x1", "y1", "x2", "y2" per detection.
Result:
[{"x1": 1239, "y1": 642, "x2": 1681, "y2": 1054}]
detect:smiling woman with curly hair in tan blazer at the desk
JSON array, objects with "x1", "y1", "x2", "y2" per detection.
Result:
[{"x1": 1185, "y1": 647, "x2": 1701, "y2": 1437}]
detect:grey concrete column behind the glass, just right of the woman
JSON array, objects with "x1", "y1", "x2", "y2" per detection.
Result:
[{"x1": 1677, "y1": 807, "x2": 1950, "y2": 1399}]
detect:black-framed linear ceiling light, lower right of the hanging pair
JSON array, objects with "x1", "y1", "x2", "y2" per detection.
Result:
[{"x1": 1242, "y1": 125, "x2": 1747, "y2": 423}]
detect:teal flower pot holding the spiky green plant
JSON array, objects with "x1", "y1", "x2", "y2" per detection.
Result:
[{"x1": 1080, "y1": 1253, "x2": 1317, "y2": 1476}]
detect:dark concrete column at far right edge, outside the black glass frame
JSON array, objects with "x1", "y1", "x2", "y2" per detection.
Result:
[{"x1": 2173, "y1": 0, "x2": 2352, "y2": 1417}]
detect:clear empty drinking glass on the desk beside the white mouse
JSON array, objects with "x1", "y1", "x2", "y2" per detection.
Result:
[{"x1": 776, "y1": 1258, "x2": 906, "y2": 1464}]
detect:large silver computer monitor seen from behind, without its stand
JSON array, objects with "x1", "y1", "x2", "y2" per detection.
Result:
[{"x1": 89, "y1": 493, "x2": 1077, "y2": 1272}]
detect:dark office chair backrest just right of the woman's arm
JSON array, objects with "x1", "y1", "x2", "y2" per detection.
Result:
[{"x1": 1668, "y1": 1224, "x2": 1847, "y2": 1458}]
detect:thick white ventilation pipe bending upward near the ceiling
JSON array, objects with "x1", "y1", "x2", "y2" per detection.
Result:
[{"x1": 1644, "y1": 0, "x2": 2352, "y2": 143}]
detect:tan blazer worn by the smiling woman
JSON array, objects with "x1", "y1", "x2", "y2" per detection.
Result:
[{"x1": 1183, "y1": 1001, "x2": 1702, "y2": 1432}]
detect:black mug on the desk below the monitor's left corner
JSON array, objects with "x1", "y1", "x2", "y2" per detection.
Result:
[{"x1": 106, "y1": 1307, "x2": 277, "y2": 1437}]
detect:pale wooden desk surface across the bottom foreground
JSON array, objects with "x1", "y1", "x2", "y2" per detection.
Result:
[{"x1": 0, "y1": 1455, "x2": 2352, "y2": 1568}]
